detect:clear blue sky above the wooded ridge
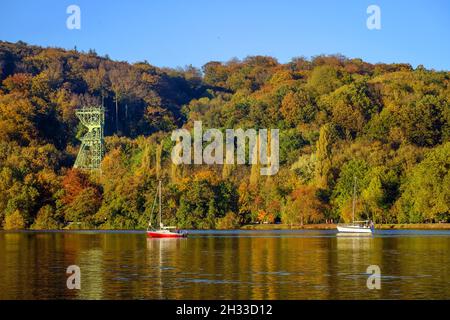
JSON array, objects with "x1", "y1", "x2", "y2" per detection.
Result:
[{"x1": 0, "y1": 0, "x2": 450, "y2": 70}]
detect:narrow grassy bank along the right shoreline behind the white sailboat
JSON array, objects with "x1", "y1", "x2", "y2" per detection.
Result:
[{"x1": 241, "y1": 223, "x2": 450, "y2": 230}]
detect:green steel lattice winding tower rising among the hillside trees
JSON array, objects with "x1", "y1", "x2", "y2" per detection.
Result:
[{"x1": 74, "y1": 106, "x2": 105, "y2": 170}]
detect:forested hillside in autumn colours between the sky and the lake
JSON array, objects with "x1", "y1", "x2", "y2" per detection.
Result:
[{"x1": 0, "y1": 42, "x2": 450, "y2": 229}]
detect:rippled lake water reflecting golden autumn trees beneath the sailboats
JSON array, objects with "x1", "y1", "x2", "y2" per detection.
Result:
[{"x1": 0, "y1": 230, "x2": 450, "y2": 299}]
